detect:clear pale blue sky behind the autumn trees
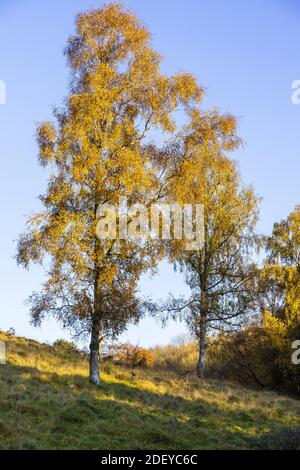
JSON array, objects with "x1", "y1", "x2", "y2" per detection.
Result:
[{"x1": 0, "y1": 0, "x2": 300, "y2": 346}]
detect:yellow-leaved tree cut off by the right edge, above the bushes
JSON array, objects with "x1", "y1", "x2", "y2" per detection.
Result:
[{"x1": 259, "y1": 206, "x2": 300, "y2": 393}]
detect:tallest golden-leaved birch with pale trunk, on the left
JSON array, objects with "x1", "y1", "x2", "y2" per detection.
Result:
[{"x1": 17, "y1": 4, "x2": 202, "y2": 384}]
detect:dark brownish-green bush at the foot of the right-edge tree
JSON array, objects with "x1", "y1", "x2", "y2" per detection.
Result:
[{"x1": 207, "y1": 323, "x2": 300, "y2": 397}]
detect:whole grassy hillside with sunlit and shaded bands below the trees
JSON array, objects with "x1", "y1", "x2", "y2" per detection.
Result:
[{"x1": 0, "y1": 333, "x2": 300, "y2": 449}]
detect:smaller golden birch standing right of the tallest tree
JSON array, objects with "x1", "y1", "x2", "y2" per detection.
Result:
[{"x1": 161, "y1": 110, "x2": 257, "y2": 377}]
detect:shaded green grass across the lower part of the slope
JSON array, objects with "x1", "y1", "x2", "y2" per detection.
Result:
[{"x1": 0, "y1": 364, "x2": 286, "y2": 450}]
